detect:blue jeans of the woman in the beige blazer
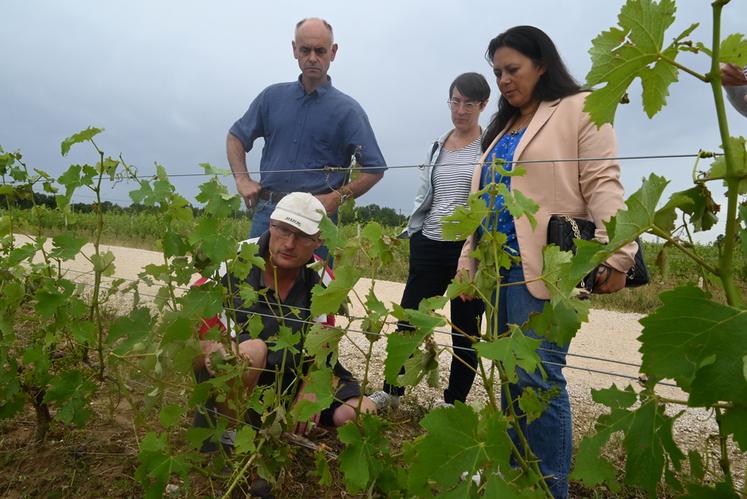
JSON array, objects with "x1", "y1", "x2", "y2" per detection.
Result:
[{"x1": 498, "y1": 266, "x2": 573, "y2": 498}]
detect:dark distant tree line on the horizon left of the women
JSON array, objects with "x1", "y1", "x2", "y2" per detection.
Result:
[{"x1": 0, "y1": 192, "x2": 407, "y2": 227}]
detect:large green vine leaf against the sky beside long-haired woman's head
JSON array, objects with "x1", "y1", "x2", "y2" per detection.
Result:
[{"x1": 584, "y1": 0, "x2": 697, "y2": 126}]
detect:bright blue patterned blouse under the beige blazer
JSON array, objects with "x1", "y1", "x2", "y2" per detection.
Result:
[{"x1": 480, "y1": 128, "x2": 526, "y2": 256}]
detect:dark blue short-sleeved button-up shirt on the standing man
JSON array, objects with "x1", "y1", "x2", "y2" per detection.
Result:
[{"x1": 230, "y1": 77, "x2": 386, "y2": 194}]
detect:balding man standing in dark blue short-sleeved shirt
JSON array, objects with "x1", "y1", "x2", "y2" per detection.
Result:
[{"x1": 226, "y1": 18, "x2": 386, "y2": 237}]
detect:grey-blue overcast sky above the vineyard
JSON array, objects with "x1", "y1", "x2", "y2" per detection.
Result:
[{"x1": 0, "y1": 0, "x2": 747, "y2": 242}]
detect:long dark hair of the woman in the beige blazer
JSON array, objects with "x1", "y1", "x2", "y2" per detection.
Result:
[{"x1": 482, "y1": 26, "x2": 581, "y2": 151}]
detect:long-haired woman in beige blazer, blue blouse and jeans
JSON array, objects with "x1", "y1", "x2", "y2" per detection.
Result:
[{"x1": 459, "y1": 26, "x2": 636, "y2": 497}]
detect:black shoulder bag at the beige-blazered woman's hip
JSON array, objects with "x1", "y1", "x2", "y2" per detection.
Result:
[{"x1": 547, "y1": 215, "x2": 651, "y2": 293}]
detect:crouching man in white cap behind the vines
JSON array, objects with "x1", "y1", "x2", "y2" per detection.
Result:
[{"x1": 195, "y1": 192, "x2": 375, "y2": 442}]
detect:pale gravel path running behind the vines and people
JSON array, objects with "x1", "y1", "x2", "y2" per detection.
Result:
[{"x1": 19, "y1": 236, "x2": 743, "y2": 466}]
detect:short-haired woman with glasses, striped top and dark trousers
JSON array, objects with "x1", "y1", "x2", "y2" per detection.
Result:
[{"x1": 371, "y1": 73, "x2": 490, "y2": 410}]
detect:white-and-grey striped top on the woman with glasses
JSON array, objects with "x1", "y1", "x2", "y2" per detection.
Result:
[{"x1": 423, "y1": 137, "x2": 481, "y2": 241}]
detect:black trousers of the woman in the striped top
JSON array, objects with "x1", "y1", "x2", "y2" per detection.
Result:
[{"x1": 384, "y1": 231, "x2": 485, "y2": 404}]
